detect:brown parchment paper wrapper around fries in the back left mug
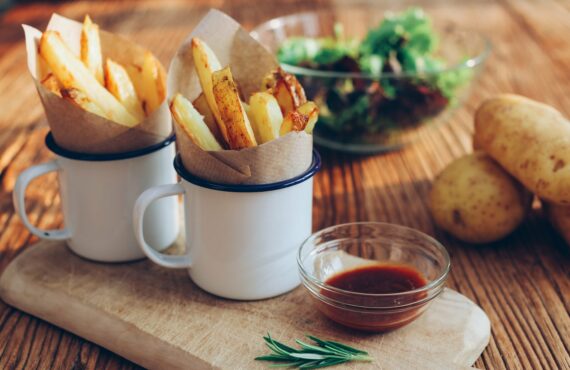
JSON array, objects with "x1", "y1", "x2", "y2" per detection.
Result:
[{"x1": 23, "y1": 14, "x2": 172, "y2": 154}]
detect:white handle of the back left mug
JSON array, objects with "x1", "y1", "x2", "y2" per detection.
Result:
[{"x1": 12, "y1": 160, "x2": 71, "y2": 240}]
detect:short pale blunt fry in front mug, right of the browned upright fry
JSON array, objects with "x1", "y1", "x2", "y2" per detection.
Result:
[{"x1": 249, "y1": 92, "x2": 283, "y2": 144}]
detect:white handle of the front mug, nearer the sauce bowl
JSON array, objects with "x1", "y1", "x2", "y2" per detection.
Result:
[{"x1": 133, "y1": 183, "x2": 190, "y2": 268}]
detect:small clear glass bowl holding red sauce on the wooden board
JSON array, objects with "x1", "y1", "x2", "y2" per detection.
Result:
[{"x1": 297, "y1": 222, "x2": 450, "y2": 332}]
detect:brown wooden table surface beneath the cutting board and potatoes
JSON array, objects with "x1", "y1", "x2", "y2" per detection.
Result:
[{"x1": 0, "y1": 0, "x2": 570, "y2": 369}]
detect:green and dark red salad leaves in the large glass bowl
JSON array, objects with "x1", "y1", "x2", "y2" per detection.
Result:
[{"x1": 277, "y1": 7, "x2": 473, "y2": 138}]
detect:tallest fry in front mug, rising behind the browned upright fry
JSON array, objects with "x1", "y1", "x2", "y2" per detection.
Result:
[{"x1": 192, "y1": 37, "x2": 228, "y2": 142}]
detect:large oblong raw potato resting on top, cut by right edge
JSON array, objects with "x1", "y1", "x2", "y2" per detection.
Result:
[{"x1": 474, "y1": 95, "x2": 570, "y2": 205}]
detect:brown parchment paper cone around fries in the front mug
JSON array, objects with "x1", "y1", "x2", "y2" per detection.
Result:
[{"x1": 168, "y1": 10, "x2": 313, "y2": 184}]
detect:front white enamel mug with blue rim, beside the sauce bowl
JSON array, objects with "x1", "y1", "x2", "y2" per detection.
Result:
[{"x1": 133, "y1": 151, "x2": 321, "y2": 300}]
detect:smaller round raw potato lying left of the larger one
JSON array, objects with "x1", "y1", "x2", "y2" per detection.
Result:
[{"x1": 429, "y1": 152, "x2": 531, "y2": 243}]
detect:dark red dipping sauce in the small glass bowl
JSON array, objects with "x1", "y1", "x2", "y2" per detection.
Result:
[{"x1": 317, "y1": 264, "x2": 427, "y2": 332}]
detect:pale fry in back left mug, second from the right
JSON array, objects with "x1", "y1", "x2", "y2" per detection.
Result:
[{"x1": 105, "y1": 59, "x2": 145, "y2": 121}]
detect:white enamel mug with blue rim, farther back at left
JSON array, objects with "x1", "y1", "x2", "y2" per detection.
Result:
[{"x1": 13, "y1": 133, "x2": 179, "y2": 262}]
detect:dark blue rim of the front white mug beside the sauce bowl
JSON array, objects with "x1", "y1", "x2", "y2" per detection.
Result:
[{"x1": 174, "y1": 149, "x2": 321, "y2": 193}]
